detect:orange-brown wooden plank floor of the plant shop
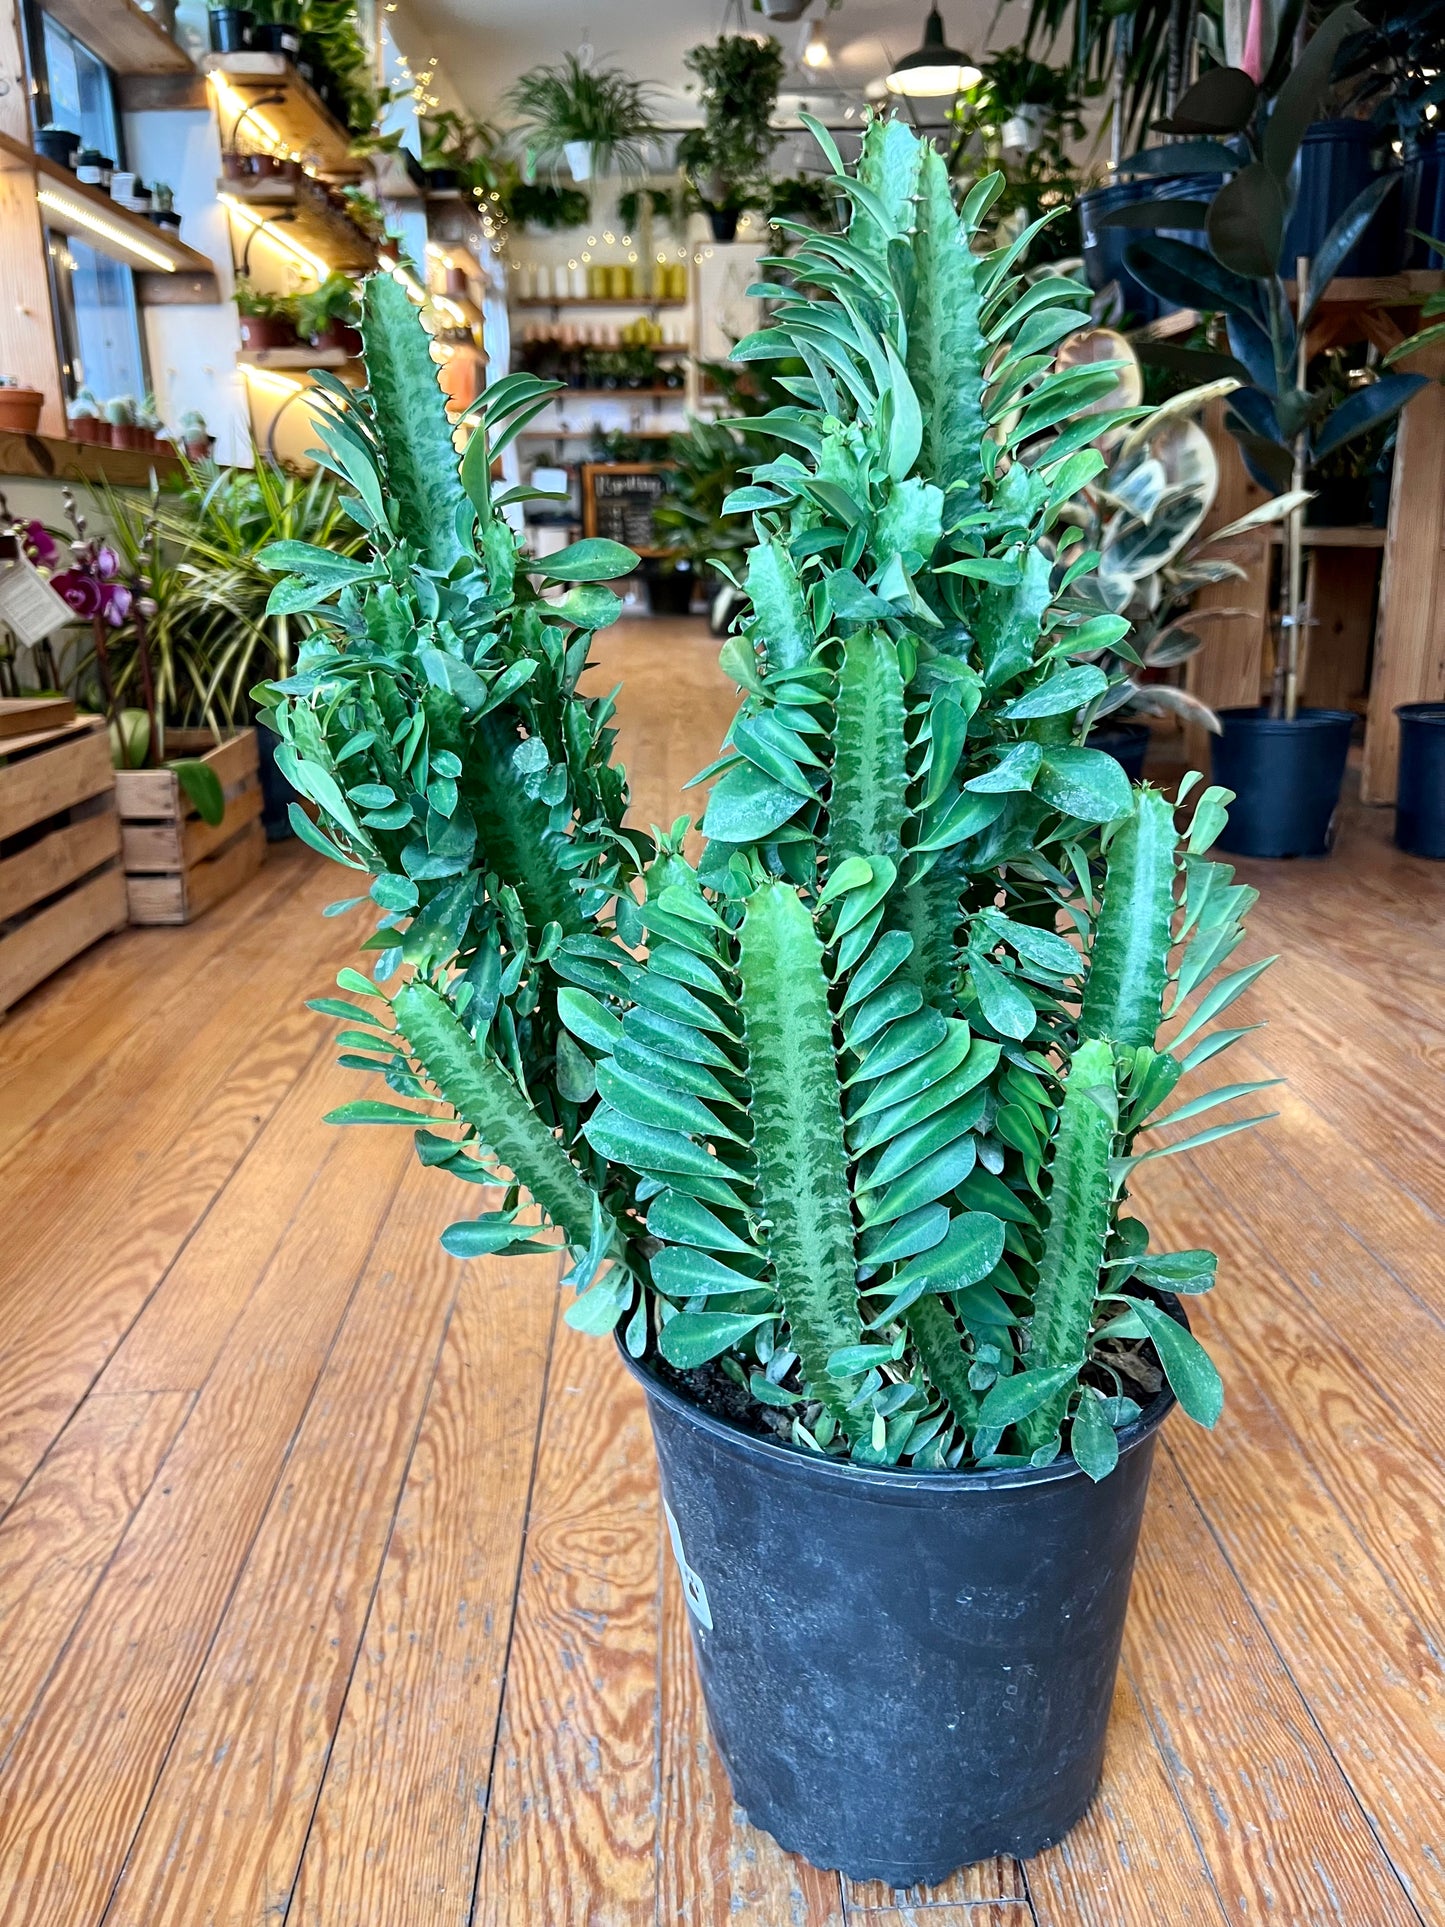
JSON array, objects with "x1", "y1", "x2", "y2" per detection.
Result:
[{"x1": 0, "y1": 622, "x2": 1445, "y2": 1927}]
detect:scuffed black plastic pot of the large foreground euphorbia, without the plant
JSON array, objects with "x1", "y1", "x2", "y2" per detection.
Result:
[{"x1": 618, "y1": 1301, "x2": 1181, "y2": 1887}]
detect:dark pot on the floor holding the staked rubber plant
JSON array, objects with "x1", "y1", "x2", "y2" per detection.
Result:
[{"x1": 1210, "y1": 709, "x2": 1354, "y2": 856}]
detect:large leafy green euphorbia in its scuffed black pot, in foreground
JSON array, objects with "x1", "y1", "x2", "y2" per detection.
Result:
[{"x1": 266, "y1": 119, "x2": 1262, "y2": 1885}]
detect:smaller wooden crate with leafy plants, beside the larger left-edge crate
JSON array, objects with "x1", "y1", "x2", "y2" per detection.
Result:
[{"x1": 116, "y1": 728, "x2": 266, "y2": 923}]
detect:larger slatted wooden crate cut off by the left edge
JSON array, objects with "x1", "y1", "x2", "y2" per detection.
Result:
[{"x1": 0, "y1": 717, "x2": 125, "y2": 1012}]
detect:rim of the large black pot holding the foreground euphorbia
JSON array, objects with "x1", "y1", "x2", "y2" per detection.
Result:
[{"x1": 613, "y1": 1291, "x2": 1189, "y2": 1505}]
